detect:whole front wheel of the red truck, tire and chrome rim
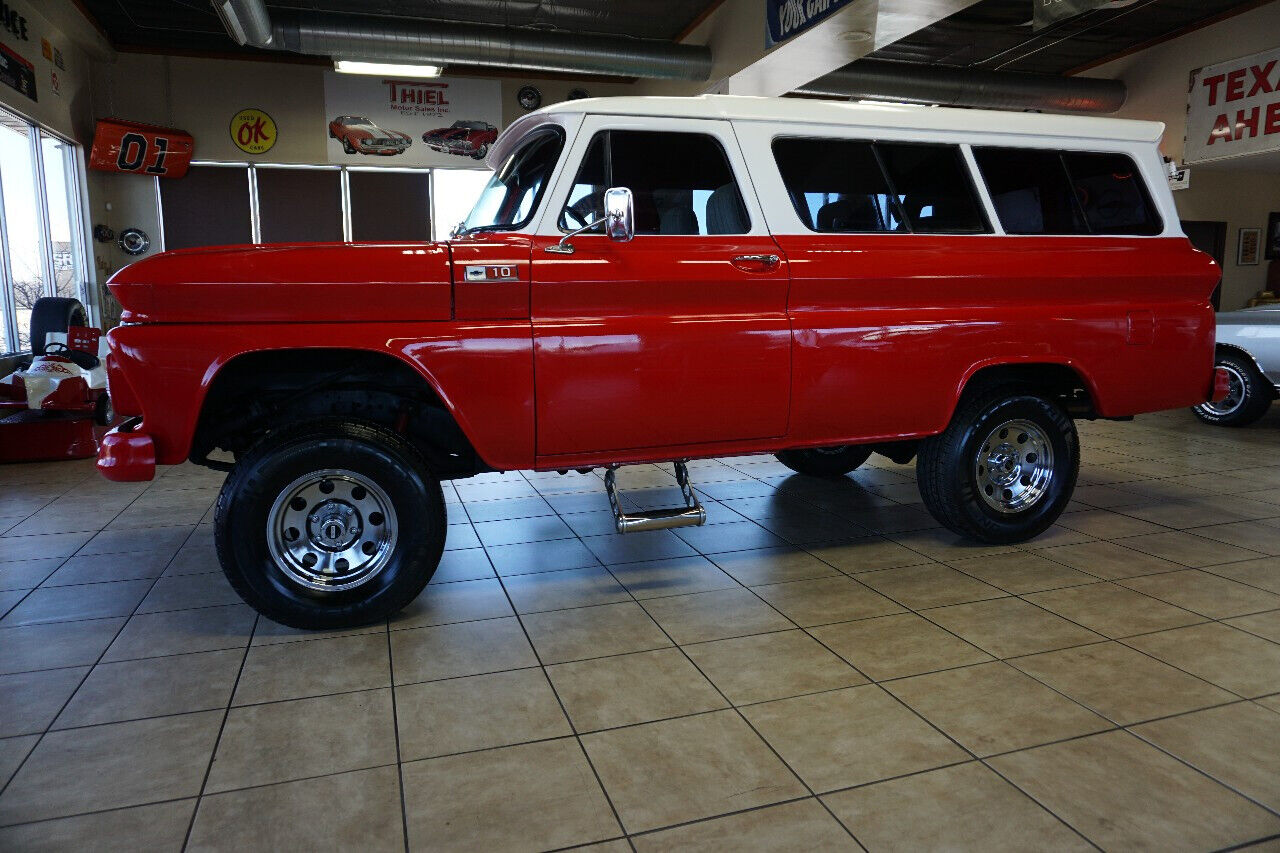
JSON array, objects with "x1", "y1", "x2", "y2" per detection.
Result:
[{"x1": 214, "y1": 420, "x2": 447, "y2": 630}]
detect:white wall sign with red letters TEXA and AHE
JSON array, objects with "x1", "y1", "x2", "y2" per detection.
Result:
[{"x1": 1183, "y1": 47, "x2": 1280, "y2": 164}]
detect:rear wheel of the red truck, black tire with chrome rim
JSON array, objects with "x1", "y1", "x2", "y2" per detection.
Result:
[{"x1": 916, "y1": 386, "x2": 1080, "y2": 544}]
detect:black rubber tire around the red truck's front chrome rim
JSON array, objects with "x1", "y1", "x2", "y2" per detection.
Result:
[{"x1": 214, "y1": 419, "x2": 448, "y2": 630}]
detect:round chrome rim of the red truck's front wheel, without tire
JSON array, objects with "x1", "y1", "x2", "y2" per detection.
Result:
[{"x1": 266, "y1": 469, "x2": 397, "y2": 592}]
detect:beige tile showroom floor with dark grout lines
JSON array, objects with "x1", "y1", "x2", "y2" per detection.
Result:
[{"x1": 0, "y1": 411, "x2": 1280, "y2": 850}]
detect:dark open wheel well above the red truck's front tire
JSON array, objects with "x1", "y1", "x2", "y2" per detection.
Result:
[{"x1": 189, "y1": 347, "x2": 489, "y2": 478}]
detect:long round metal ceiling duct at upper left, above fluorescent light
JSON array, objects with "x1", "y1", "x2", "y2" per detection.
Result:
[{"x1": 212, "y1": 0, "x2": 712, "y2": 81}]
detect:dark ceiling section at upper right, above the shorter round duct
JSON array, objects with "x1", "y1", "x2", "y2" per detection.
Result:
[{"x1": 872, "y1": 0, "x2": 1262, "y2": 74}]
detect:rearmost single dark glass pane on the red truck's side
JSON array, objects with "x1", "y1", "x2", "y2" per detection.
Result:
[{"x1": 1062, "y1": 151, "x2": 1164, "y2": 237}]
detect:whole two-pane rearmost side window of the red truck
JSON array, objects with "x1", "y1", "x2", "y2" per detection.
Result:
[{"x1": 973, "y1": 147, "x2": 1164, "y2": 237}]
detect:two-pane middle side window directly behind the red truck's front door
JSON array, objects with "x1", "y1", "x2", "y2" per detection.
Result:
[{"x1": 773, "y1": 138, "x2": 987, "y2": 234}]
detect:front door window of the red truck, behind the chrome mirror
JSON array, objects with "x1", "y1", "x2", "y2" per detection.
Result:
[{"x1": 559, "y1": 131, "x2": 751, "y2": 234}]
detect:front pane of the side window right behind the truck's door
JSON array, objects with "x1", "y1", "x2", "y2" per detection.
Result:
[{"x1": 773, "y1": 138, "x2": 905, "y2": 233}]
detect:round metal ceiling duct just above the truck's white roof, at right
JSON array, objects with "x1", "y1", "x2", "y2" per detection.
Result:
[{"x1": 795, "y1": 59, "x2": 1128, "y2": 113}]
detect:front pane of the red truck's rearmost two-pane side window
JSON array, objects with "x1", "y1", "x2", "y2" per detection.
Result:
[{"x1": 973, "y1": 147, "x2": 1089, "y2": 234}]
